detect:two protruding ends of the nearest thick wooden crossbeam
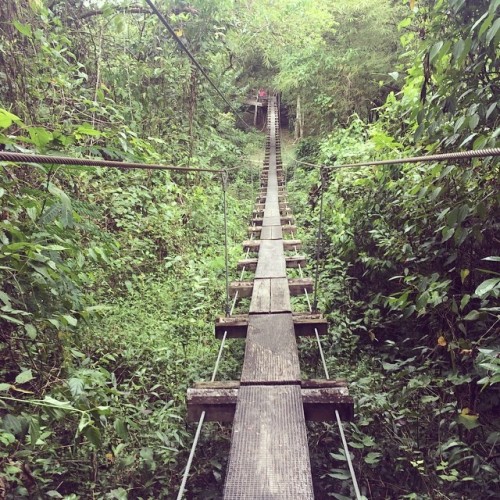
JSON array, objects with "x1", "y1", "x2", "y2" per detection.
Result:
[{"x1": 187, "y1": 386, "x2": 354, "y2": 422}]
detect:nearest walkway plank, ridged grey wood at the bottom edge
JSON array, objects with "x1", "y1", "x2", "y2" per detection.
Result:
[{"x1": 224, "y1": 386, "x2": 314, "y2": 500}]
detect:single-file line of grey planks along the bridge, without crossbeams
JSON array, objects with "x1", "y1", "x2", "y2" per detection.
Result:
[{"x1": 224, "y1": 97, "x2": 314, "y2": 500}]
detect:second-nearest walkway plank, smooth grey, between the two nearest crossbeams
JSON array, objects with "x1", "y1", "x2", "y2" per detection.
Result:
[{"x1": 241, "y1": 313, "x2": 300, "y2": 385}]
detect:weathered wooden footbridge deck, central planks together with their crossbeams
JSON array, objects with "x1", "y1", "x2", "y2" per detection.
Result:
[{"x1": 188, "y1": 97, "x2": 353, "y2": 500}]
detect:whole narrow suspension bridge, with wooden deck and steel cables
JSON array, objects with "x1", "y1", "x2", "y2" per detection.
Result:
[{"x1": 0, "y1": 0, "x2": 500, "y2": 494}]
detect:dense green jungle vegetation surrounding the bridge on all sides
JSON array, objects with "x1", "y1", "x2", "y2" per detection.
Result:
[{"x1": 0, "y1": 0, "x2": 500, "y2": 500}]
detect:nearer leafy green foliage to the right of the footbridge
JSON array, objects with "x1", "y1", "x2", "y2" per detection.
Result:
[{"x1": 289, "y1": 1, "x2": 500, "y2": 498}]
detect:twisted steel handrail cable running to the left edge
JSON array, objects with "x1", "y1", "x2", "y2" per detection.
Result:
[{"x1": 0, "y1": 151, "x2": 224, "y2": 174}]
